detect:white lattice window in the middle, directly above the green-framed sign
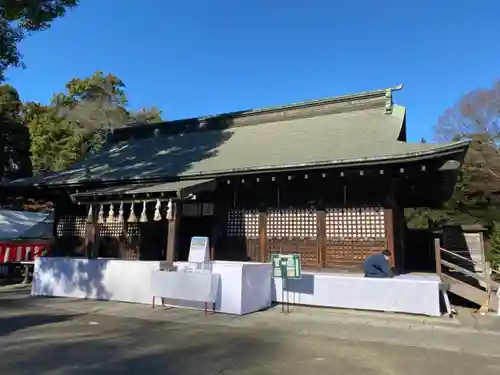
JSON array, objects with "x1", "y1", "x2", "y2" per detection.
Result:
[{"x1": 266, "y1": 209, "x2": 318, "y2": 238}]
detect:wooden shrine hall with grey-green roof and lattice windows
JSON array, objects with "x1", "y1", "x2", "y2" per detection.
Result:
[{"x1": 12, "y1": 86, "x2": 469, "y2": 271}]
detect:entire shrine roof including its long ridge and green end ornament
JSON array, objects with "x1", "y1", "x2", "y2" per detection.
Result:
[{"x1": 12, "y1": 89, "x2": 468, "y2": 189}]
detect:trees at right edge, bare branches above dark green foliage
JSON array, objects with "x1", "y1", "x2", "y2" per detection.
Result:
[{"x1": 420, "y1": 81, "x2": 500, "y2": 226}]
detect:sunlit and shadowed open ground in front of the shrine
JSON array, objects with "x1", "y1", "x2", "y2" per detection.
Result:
[{"x1": 0, "y1": 287, "x2": 500, "y2": 375}]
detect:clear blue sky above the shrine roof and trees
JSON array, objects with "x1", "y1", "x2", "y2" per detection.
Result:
[{"x1": 4, "y1": 0, "x2": 500, "y2": 140}]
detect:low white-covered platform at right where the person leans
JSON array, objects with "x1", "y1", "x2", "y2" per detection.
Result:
[{"x1": 272, "y1": 272, "x2": 441, "y2": 316}]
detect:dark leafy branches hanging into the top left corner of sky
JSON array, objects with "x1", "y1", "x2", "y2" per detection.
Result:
[{"x1": 0, "y1": 0, "x2": 79, "y2": 82}]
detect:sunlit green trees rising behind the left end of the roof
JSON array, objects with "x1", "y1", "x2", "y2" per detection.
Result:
[{"x1": 11, "y1": 72, "x2": 161, "y2": 174}]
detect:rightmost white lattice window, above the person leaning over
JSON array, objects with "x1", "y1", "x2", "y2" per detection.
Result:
[{"x1": 326, "y1": 207, "x2": 385, "y2": 239}]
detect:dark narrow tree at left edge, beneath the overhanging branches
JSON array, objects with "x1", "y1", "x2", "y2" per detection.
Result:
[{"x1": 0, "y1": 85, "x2": 31, "y2": 179}]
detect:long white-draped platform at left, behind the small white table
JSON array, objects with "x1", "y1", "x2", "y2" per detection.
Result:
[{"x1": 31, "y1": 257, "x2": 271, "y2": 315}]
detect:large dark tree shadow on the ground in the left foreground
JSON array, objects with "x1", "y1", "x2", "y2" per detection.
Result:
[{"x1": 0, "y1": 317, "x2": 283, "y2": 375}]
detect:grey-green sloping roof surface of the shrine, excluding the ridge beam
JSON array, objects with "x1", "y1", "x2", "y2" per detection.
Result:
[{"x1": 11, "y1": 90, "x2": 467, "y2": 185}]
